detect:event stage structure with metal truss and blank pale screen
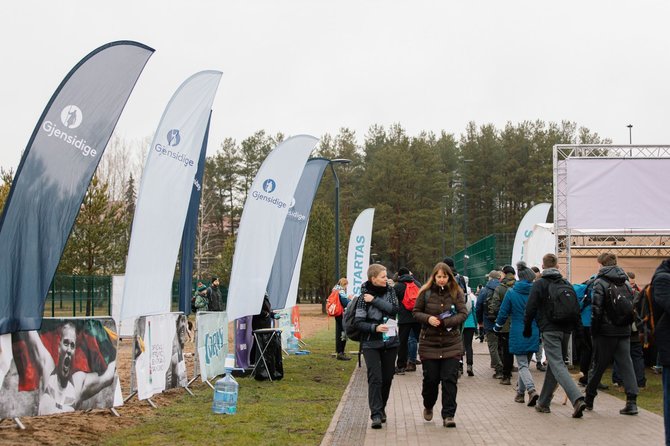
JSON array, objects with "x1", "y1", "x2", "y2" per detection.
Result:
[{"x1": 553, "y1": 145, "x2": 670, "y2": 285}]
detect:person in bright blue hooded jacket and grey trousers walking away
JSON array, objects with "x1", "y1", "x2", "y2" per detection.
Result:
[{"x1": 493, "y1": 262, "x2": 540, "y2": 407}]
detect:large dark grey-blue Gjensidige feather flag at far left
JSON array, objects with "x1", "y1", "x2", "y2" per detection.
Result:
[{"x1": 0, "y1": 42, "x2": 154, "y2": 334}]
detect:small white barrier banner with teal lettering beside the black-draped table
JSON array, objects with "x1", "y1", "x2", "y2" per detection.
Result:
[{"x1": 195, "y1": 311, "x2": 228, "y2": 382}]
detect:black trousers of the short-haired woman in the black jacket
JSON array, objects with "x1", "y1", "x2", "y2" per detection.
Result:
[{"x1": 363, "y1": 347, "x2": 398, "y2": 419}]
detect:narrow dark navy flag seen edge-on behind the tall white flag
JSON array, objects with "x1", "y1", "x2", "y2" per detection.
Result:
[{"x1": 179, "y1": 112, "x2": 212, "y2": 316}]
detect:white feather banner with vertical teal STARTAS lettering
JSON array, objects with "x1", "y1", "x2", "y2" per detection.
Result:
[{"x1": 347, "y1": 208, "x2": 375, "y2": 296}]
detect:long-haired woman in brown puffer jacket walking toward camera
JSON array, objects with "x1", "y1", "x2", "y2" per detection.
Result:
[{"x1": 413, "y1": 262, "x2": 468, "y2": 427}]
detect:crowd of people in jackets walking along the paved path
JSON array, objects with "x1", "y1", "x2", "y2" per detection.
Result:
[{"x1": 336, "y1": 252, "x2": 670, "y2": 444}]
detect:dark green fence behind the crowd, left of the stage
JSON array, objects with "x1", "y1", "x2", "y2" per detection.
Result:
[{"x1": 453, "y1": 233, "x2": 515, "y2": 289}]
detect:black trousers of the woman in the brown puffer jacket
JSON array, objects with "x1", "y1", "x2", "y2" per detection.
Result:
[{"x1": 421, "y1": 358, "x2": 459, "y2": 419}]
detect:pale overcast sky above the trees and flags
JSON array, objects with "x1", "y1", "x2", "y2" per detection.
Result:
[{"x1": 0, "y1": 0, "x2": 670, "y2": 169}]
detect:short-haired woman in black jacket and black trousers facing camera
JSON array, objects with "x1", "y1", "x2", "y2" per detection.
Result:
[{"x1": 354, "y1": 264, "x2": 399, "y2": 429}]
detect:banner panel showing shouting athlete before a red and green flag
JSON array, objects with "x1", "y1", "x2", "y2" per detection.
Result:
[{"x1": 0, "y1": 317, "x2": 119, "y2": 418}]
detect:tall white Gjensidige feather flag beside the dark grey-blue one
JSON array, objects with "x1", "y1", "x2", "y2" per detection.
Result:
[{"x1": 121, "y1": 71, "x2": 221, "y2": 319}]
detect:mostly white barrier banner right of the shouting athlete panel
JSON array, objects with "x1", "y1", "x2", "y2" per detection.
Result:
[{"x1": 133, "y1": 313, "x2": 188, "y2": 400}]
